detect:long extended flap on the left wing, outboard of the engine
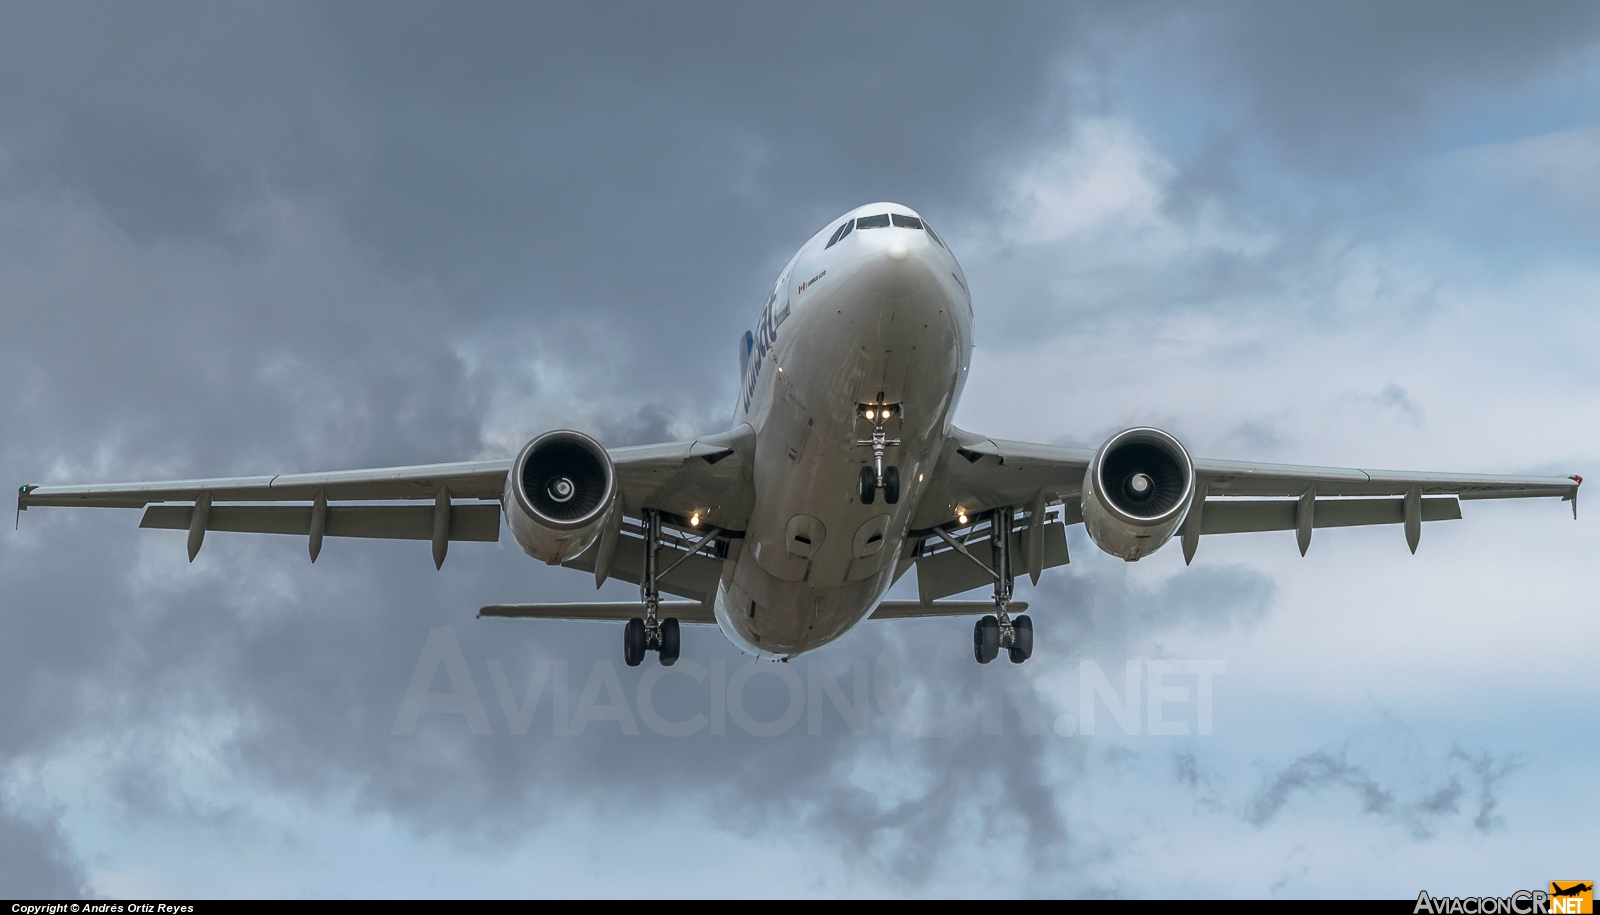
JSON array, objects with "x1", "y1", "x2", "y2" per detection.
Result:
[{"x1": 139, "y1": 505, "x2": 499, "y2": 542}]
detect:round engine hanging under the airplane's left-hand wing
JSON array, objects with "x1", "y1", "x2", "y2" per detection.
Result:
[{"x1": 501, "y1": 430, "x2": 616, "y2": 565}]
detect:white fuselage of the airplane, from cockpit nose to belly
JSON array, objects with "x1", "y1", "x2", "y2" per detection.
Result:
[{"x1": 715, "y1": 203, "x2": 973, "y2": 657}]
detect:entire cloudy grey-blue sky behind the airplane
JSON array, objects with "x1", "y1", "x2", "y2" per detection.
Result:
[{"x1": 0, "y1": 2, "x2": 1600, "y2": 897}]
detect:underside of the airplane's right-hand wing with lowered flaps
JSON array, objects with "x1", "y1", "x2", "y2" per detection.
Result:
[{"x1": 909, "y1": 429, "x2": 1582, "y2": 591}]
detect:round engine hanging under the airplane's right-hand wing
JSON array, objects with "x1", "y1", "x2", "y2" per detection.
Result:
[{"x1": 1083, "y1": 427, "x2": 1195, "y2": 561}]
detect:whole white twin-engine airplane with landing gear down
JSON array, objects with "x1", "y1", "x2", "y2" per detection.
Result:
[{"x1": 18, "y1": 203, "x2": 1582, "y2": 665}]
